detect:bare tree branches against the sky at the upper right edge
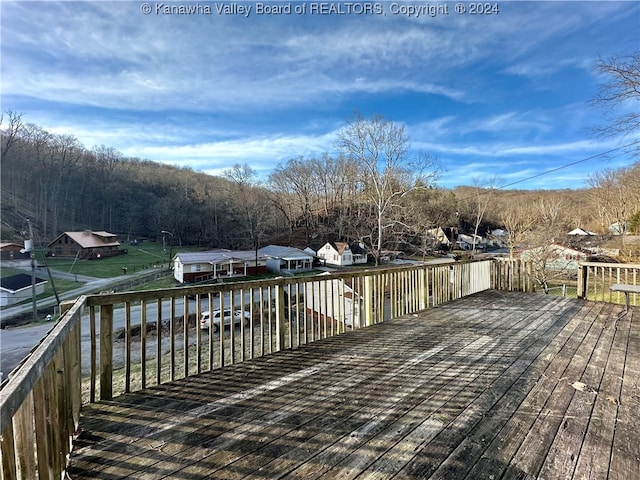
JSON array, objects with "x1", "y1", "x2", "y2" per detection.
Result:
[{"x1": 592, "y1": 51, "x2": 640, "y2": 141}]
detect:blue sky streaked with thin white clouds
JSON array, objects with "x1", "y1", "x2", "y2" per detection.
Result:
[{"x1": 0, "y1": 0, "x2": 640, "y2": 189}]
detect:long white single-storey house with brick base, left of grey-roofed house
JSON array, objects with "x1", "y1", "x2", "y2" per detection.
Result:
[{"x1": 173, "y1": 249, "x2": 267, "y2": 283}]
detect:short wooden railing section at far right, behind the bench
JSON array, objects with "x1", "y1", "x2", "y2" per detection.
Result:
[{"x1": 578, "y1": 262, "x2": 640, "y2": 305}]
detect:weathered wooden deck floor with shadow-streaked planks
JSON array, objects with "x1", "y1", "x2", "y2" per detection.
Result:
[{"x1": 69, "y1": 291, "x2": 640, "y2": 480}]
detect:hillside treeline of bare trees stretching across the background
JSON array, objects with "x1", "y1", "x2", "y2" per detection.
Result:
[{"x1": 1, "y1": 112, "x2": 640, "y2": 253}]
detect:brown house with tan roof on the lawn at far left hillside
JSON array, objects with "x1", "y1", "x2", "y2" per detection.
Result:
[{"x1": 47, "y1": 230, "x2": 121, "y2": 259}]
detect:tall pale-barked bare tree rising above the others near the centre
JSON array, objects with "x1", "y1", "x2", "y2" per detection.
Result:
[{"x1": 338, "y1": 114, "x2": 437, "y2": 264}]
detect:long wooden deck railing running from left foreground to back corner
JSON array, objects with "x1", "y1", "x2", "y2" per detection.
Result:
[{"x1": 0, "y1": 260, "x2": 533, "y2": 480}]
